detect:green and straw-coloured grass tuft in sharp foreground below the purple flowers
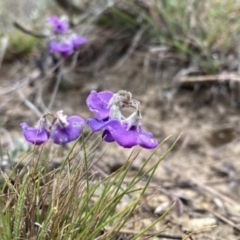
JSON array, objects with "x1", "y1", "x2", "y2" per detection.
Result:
[{"x1": 0, "y1": 136, "x2": 174, "y2": 240}]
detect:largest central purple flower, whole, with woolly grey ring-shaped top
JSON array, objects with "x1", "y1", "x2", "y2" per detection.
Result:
[{"x1": 87, "y1": 91, "x2": 158, "y2": 149}]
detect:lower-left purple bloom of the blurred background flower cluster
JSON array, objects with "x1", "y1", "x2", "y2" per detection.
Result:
[{"x1": 49, "y1": 41, "x2": 74, "y2": 57}]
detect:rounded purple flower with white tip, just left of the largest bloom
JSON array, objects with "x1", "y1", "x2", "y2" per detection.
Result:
[{"x1": 51, "y1": 115, "x2": 85, "y2": 145}]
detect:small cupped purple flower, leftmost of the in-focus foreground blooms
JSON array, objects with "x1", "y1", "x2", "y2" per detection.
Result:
[{"x1": 20, "y1": 122, "x2": 49, "y2": 145}]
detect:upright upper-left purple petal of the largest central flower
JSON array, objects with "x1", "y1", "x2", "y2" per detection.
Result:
[{"x1": 86, "y1": 91, "x2": 113, "y2": 120}]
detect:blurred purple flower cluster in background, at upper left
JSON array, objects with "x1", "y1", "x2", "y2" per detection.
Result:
[{"x1": 49, "y1": 16, "x2": 87, "y2": 57}]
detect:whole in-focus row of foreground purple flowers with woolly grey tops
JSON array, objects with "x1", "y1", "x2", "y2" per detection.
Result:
[{"x1": 21, "y1": 90, "x2": 158, "y2": 149}]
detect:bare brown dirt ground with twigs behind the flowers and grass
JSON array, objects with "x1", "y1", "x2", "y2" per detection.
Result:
[{"x1": 0, "y1": 52, "x2": 240, "y2": 240}]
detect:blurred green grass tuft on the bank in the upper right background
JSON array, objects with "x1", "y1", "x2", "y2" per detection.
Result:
[{"x1": 92, "y1": 0, "x2": 240, "y2": 74}]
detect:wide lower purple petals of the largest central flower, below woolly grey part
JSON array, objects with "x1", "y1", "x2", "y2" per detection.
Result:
[{"x1": 88, "y1": 118, "x2": 158, "y2": 149}]
